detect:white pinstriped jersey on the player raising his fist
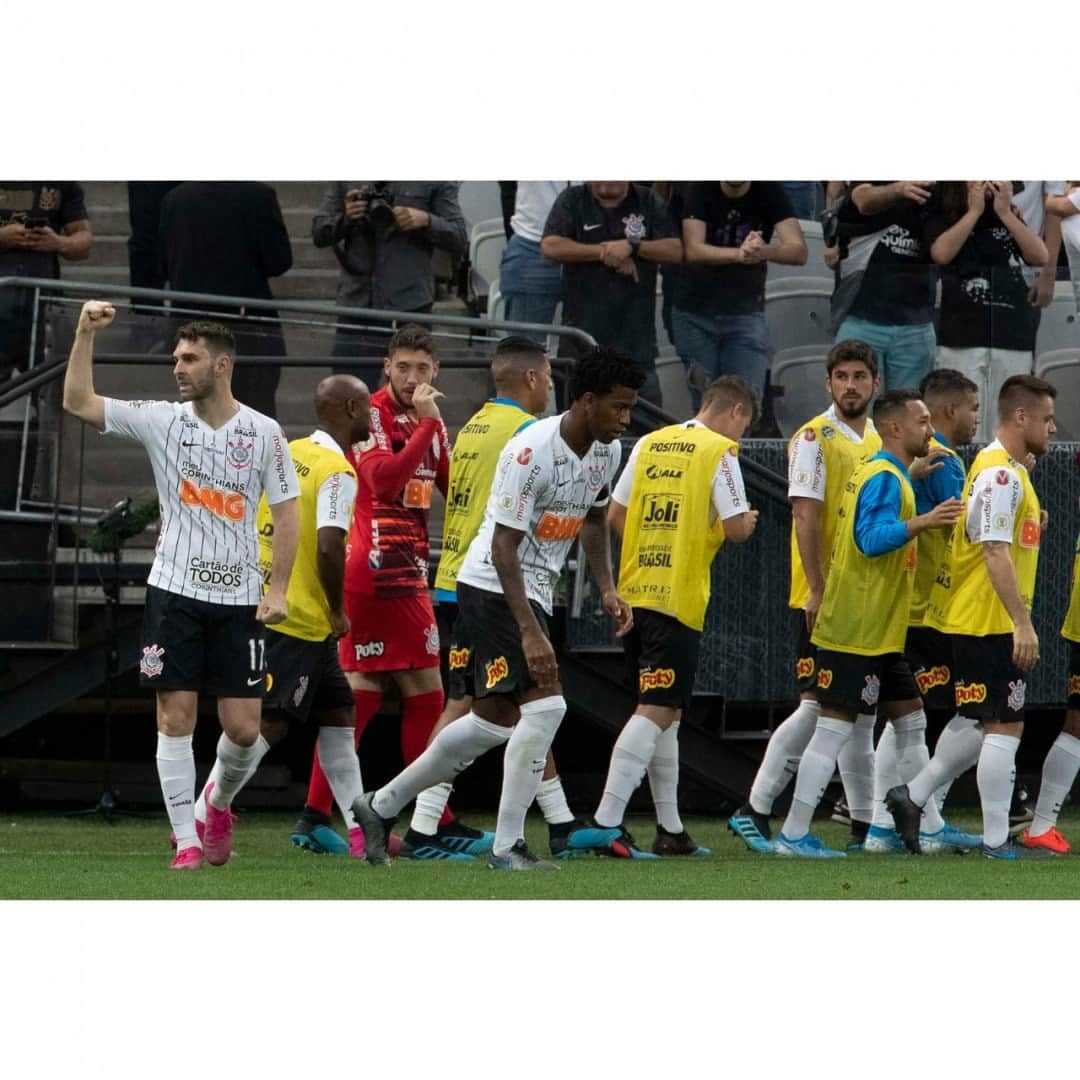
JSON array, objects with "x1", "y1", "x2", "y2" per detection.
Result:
[{"x1": 105, "y1": 397, "x2": 300, "y2": 606}]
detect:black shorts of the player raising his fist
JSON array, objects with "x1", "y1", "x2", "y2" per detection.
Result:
[{"x1": 138, "y1": 585, "x2": 266, "y2": 698}]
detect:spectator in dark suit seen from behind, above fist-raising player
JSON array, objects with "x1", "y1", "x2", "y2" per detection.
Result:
[{"x1": 161, "y1": 180, "x2": 293, "y2": 417}]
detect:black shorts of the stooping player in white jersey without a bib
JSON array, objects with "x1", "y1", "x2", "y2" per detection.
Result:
[{"x1": 455, "y1": 581, "x2": 551, "y2": 701}]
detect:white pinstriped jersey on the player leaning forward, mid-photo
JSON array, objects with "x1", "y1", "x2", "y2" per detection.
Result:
[{"x1": 458, "y1": 414, "x2": 622, "y2": 615}]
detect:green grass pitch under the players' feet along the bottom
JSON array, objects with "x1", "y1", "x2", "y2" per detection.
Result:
[{"x1": 0, "y1": 810, "x2": 1080, "y2": 900}]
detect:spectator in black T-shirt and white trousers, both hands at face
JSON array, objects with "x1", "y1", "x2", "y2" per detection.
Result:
[{"x1": 926, "y1": 180, "x2": 1047, "y2": 443}]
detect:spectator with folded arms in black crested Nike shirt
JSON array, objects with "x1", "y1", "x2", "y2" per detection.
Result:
[{"x1": 540, "y1": 180, "x2": 683, "y2": 405}]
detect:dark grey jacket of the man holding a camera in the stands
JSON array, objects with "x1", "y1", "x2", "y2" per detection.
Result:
[{"x1": 311, "y1": 180, "x2": 469, "y2": 311}]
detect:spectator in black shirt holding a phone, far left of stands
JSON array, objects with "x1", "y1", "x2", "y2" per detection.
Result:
[{"x1": 0, "y1": 180, "x2": 94, "y2": 509}]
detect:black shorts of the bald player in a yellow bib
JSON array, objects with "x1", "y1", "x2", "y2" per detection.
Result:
[{"x1": 262, "y1": 627, "x2": 353, "y2": 720}]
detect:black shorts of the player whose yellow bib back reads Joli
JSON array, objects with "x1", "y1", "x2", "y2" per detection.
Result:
[{"x1": 625, "y1": 608, "x2": 701, "y2": 708}]
